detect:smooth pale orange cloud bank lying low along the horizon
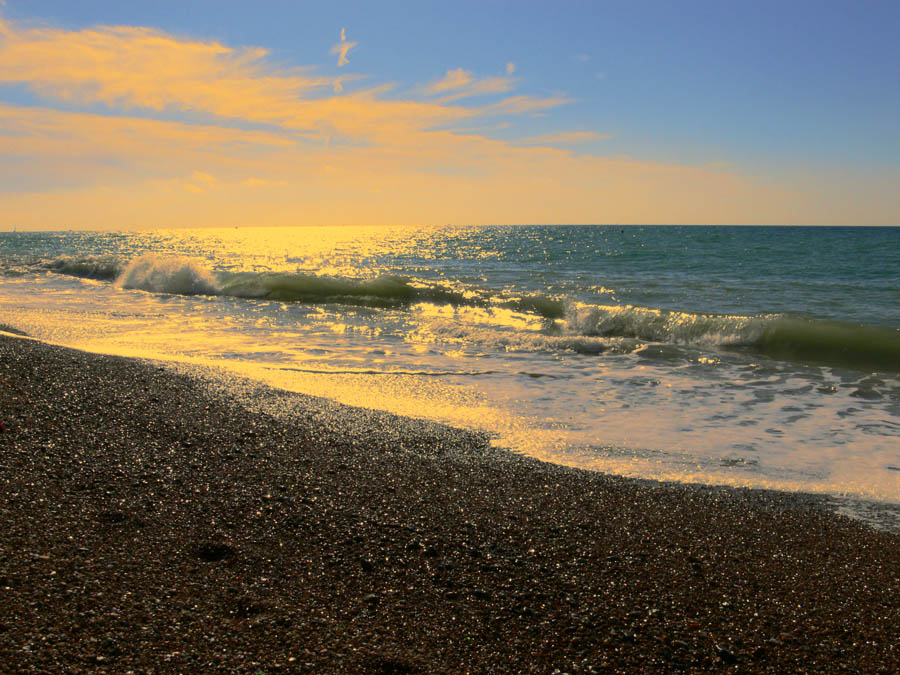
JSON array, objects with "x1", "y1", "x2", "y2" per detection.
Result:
[{"x1": 0, "y1": 99, "x2": 828, "y2": 228}]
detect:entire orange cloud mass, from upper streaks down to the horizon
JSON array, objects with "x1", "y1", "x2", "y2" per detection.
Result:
[{"x1": 0, "y1": 18, "x2": 852, "y2": 227}]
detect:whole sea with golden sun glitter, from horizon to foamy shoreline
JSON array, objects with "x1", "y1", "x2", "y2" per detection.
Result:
[{"x1": 0, "y1": 225, "x2": 900, "y2": 516}]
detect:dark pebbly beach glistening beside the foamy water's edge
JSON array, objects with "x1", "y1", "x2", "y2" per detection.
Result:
[{"x1": 0, "y1": 337, "x2": 900, "y2": 673}]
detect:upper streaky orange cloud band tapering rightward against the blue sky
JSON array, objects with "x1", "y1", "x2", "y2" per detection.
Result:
[{"x1": 0, "y1": 19, "x2": 474, "y2": 138}]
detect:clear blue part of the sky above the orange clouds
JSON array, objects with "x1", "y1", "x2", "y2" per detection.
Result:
[{"x1": 0, "y1": 0, "x2": 900, "y2": 224}]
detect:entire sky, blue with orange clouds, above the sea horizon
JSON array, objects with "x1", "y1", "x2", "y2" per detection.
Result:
[{"x1": 0, "y1": 0, "x2": 900, "y2": 230}]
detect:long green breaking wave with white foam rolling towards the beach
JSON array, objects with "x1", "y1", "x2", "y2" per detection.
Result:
[{"x1": 43, "y1": 254, "x2": 900, "y2": 371}]
